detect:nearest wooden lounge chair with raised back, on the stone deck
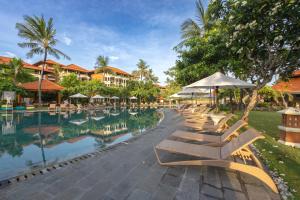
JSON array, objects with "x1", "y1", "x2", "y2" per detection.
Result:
[{"x1": 154, "y1": 129, "x2": 278, "y2": 193}]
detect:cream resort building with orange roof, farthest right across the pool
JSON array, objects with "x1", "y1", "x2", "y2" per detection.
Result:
[{"x1": 90, "y1": 66, "x2": 132, "y2": 87}]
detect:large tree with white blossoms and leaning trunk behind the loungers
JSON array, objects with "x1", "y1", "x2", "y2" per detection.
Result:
[{"x1": 210, "y1": 0, "x2": 300, "y2": 119}]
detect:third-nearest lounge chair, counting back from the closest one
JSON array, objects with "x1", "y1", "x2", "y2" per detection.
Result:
[{"x1": 184, "y1": 114, "x2": 234, "y2": 132}]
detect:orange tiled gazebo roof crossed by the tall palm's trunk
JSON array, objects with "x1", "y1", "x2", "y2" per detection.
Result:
[{"x1": 20, "y1": 80, "x2": 64, "y2": 92}]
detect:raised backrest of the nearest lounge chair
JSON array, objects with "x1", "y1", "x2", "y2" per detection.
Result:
[{"x1": 221, "y1": 128, "x2": 265, "y2": 159}]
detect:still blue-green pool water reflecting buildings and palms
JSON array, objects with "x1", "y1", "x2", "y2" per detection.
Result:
[{"x1": 0, "y1": 109, "x2": 160, "y2": 180}]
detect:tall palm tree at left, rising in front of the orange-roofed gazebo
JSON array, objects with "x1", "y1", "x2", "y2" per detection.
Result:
[{"x1": 16, "y1": 16, "x2": 70, "y2": 106}]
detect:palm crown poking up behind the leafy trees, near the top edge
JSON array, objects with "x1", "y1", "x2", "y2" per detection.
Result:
[{"x1": 181, "y1": 0, "x2": 209, "y2": 40}]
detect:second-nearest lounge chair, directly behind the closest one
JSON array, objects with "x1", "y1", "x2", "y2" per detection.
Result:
[{"x1": 171, "y1": 120, "x2": 247, "y2": 145}]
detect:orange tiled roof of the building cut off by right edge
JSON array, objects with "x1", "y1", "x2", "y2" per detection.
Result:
[{"x1": 272, "y1": 77, "x2": 300, "y2": 94}]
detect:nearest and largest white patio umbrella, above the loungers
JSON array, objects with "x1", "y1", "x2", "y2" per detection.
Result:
[{"x1": 186, "y1": 72, "x2": 255, "y2": 109}]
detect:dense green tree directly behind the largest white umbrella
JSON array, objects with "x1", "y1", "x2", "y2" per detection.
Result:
[{"x1": 170, "y1": 24, "x2": 231, "y2": 85}]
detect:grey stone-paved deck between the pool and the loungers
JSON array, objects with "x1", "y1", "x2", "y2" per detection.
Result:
[{"x1": 0, "y1": 110, "x2": 280, "y2": 200}]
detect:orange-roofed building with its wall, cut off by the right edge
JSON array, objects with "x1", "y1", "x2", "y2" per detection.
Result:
[{"x1": 273, "y1": 70, "x2": 300, "y2": 104}]
